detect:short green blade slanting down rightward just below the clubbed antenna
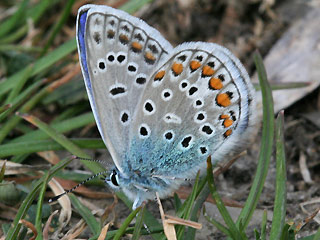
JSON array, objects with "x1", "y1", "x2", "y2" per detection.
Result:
[{"x1": 68, "y1": 193, "x2": 101, "y2": 235}]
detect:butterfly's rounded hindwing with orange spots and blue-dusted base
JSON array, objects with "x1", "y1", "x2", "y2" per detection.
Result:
[{"x1": 127, "y1": 42, "x2": 255, "y2": 177}]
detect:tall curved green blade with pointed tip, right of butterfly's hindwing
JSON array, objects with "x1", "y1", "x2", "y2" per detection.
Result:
[{"x1": 237, "y1": 51, "x2": 274, "y2": 228}]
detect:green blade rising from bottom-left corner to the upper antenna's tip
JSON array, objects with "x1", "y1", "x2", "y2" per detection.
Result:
[{"x1": 6, "y1": 159, "x2": 72, "y2": 240}]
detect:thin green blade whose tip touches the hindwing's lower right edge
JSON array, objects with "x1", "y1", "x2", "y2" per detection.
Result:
[{"x1": 207, "y1": 157, "x2": 242, "y2": 239}]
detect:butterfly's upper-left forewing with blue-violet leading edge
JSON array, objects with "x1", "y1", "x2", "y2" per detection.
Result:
[{"x1": 77, "y1": 5, "x2": 172, "y2": 170}]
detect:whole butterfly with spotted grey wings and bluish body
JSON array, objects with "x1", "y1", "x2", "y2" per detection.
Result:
[{"x1": 77, "y1": 5, "x2": 256, "y2": 209}]
